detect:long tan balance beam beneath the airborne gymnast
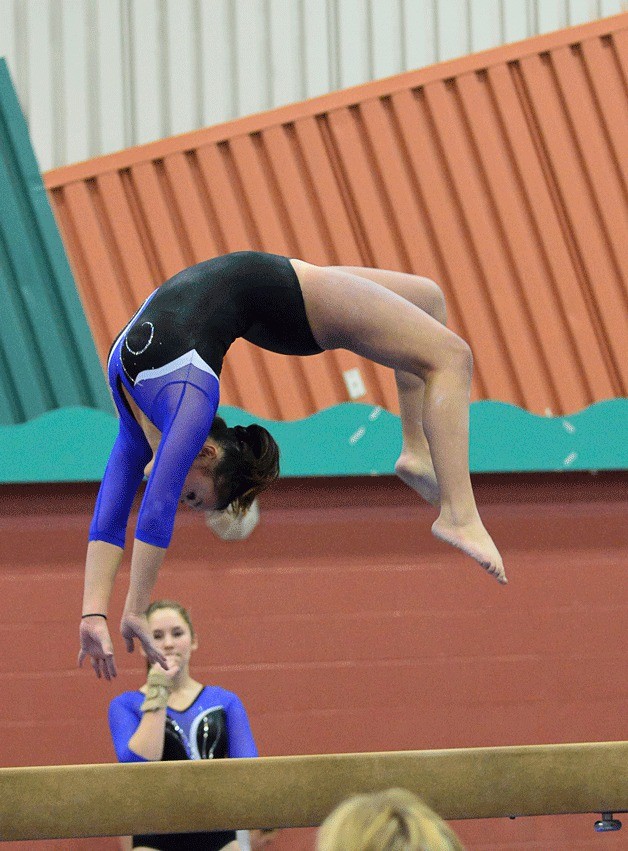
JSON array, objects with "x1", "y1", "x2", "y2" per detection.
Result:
[{"x1": 0, "y1": 742, "x2": 628, "y2": 840}]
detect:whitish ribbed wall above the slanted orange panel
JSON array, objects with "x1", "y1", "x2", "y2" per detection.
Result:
[{"x1": 0, "y1": 0, "x2": 625, "y2": 169}]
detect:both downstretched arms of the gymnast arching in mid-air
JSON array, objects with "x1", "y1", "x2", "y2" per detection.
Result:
[{"x1": 79, "y1": 364, "x2": 219, "y2": 679}]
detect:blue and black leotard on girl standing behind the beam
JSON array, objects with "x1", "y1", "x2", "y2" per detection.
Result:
[{"x1": 109, "y1": 686, "x2": 257, "y2": 851}]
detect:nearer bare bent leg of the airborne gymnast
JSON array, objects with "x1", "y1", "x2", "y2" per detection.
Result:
[{"x1": 291, "y1": 260, "x2": 507, "y2": 584}]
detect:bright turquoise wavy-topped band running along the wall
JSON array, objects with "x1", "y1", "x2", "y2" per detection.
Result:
[{"x1": 0, "y1": 399, "x2": 628, "y2": 484}]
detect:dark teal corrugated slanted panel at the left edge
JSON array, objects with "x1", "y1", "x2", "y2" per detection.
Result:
[{"x1": 0, "y1": 59, "x2": 113, "y2": 425}]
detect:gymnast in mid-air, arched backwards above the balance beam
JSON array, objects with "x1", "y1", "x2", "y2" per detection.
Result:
[{"x1": 79, "y1": 251, "x2": 507, "y2": 679}]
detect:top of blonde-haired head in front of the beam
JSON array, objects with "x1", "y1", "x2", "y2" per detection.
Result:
[{"x1": 316, "y1": 789, "x2": 464, "y2": 851}]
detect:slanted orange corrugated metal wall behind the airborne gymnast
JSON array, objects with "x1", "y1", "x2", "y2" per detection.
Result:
[{"x1": 46, "y1": 14, "x2": 628, "y2": 419}]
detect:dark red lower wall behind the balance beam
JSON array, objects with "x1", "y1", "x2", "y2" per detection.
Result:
[{"x1": 0, "y1": 473, "x2": 628, "y2": 851}]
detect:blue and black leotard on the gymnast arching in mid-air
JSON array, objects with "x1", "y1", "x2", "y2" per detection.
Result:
[{"x1": 89, "y1": 251, "x2": 321, "y2": 548}]
